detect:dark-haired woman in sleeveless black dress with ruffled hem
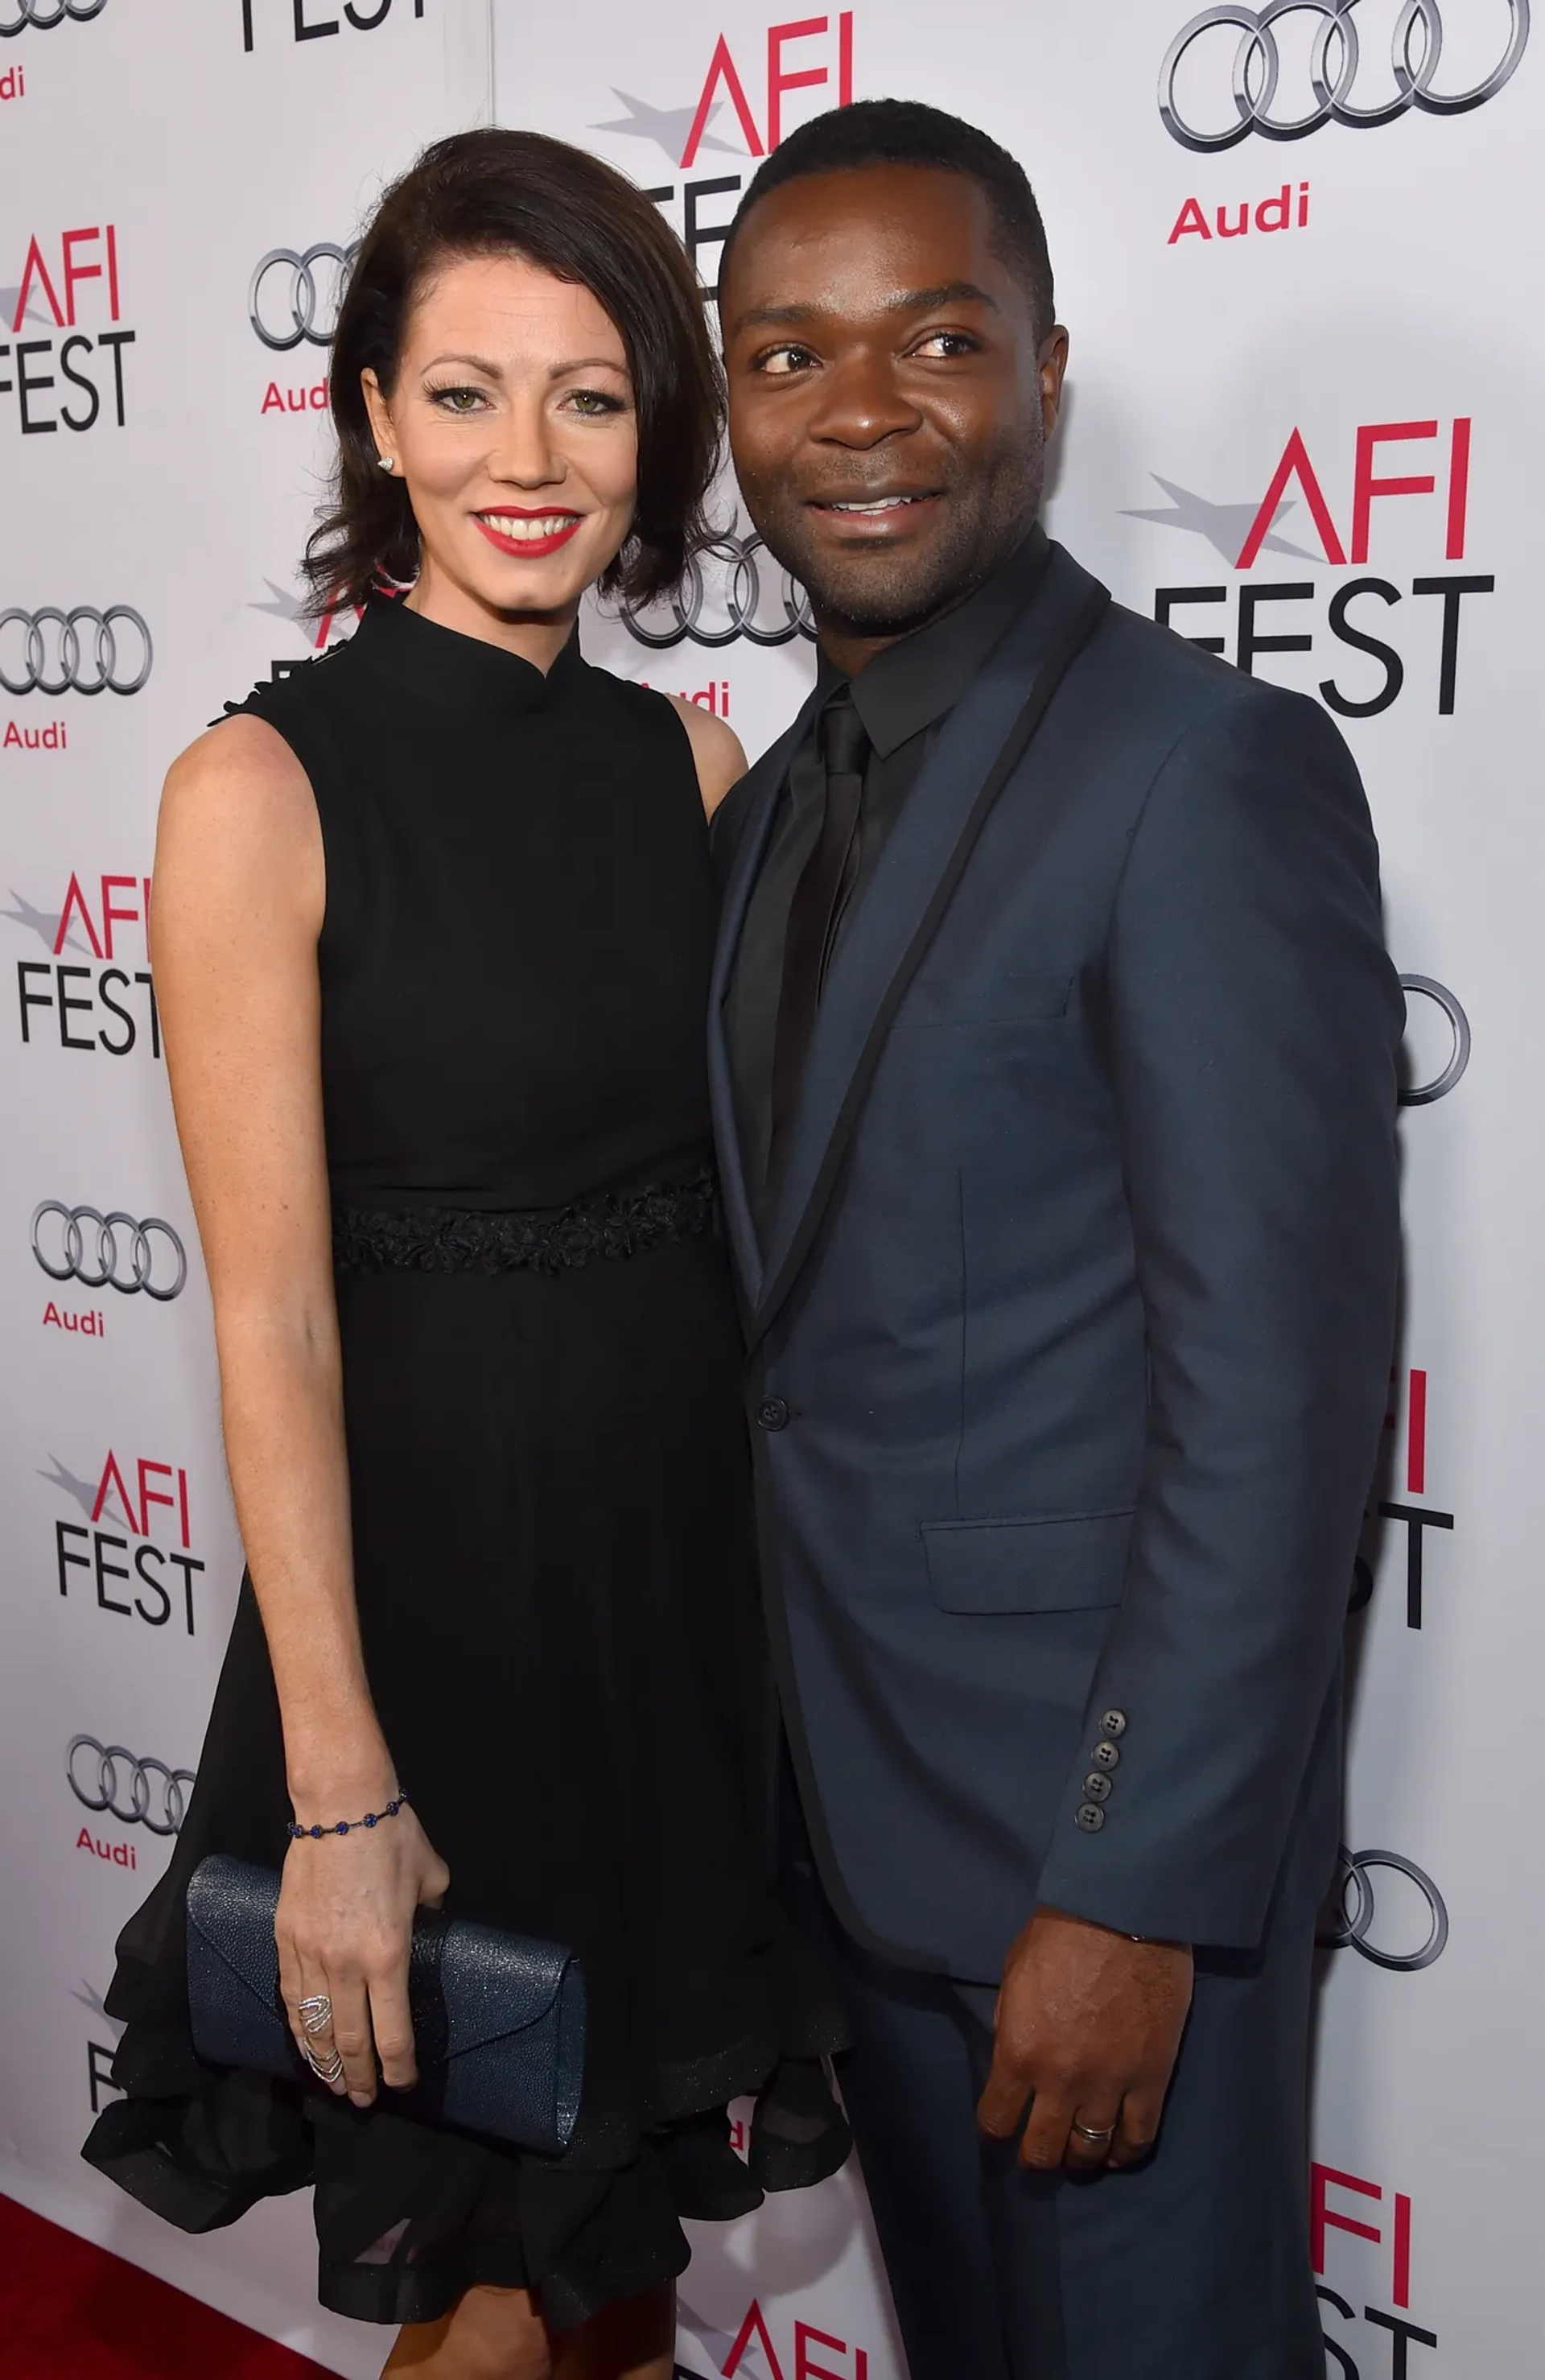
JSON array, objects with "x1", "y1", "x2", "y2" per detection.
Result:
[{"x1": 86, "y1": 131, "x2": 845, "y2": 2380}]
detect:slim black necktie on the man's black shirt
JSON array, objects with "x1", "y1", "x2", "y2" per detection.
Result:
[{"x1": 767, "y1": 688, "x2": 869, "y2": 1192}]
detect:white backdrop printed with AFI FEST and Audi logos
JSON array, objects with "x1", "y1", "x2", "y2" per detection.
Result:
[{"x1": 0, "y1": 0, "x2": 1545, "y2": 2380}]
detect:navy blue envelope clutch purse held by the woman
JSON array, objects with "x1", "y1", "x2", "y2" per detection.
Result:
[{"x1": 188, "y1": 1856, "x2": 586, "y2": 2156}]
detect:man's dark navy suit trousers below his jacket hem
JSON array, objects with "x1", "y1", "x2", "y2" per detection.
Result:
[{"x1": 829, "y1": 1763, "x2": 1336, "y2": 2380}]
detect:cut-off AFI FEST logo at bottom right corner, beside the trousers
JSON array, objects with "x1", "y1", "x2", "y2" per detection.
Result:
[{"x1": 1309, "y1": 2166, "x2": 1438, "y2": 2380}]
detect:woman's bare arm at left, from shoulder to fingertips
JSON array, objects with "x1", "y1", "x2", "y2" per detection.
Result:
[{"x1": 152, "y1": 719, "x2": 445, "y2": 2099}]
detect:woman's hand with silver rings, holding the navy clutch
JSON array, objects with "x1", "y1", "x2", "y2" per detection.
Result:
[{"x1": 274, "y1": 1788, "x2": 450, "y2": 2106}]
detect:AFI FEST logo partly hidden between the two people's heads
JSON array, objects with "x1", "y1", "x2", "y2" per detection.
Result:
[{"x1": 591, "y1": 10, "x2": 855, "y2": 298}]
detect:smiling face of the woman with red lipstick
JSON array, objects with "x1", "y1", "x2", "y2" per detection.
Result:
[{"x1": 365, "y1": 254, "x2": 638, "y2": 633}]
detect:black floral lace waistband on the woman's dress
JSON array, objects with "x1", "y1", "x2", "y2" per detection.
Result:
[{"x1": 333, "y1": 1169, "x2": 716, "y2": 1273}]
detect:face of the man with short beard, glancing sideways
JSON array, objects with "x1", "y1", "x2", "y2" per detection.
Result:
[{"x1": 719, "y1": 164, "x2": 1066, "y2": 637}]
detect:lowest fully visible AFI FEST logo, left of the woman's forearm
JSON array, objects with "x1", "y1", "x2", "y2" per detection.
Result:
[{"x1": 38, "y1": 1447, "x2": 207, "y2": 1635}]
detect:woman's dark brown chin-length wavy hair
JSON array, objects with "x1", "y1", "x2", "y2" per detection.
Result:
[{"x1": 303, "y1": 131, "x2": 723, "y2": 609}]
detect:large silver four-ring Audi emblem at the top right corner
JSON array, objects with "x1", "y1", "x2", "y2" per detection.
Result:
[{"x1": 1160, "y1": 0, "x2": 1528, "y2": 157}]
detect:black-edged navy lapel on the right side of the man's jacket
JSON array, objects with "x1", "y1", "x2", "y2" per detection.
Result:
[{"x1": 752, "y1": 547, "x2": 1110, "y2": 1345}]
